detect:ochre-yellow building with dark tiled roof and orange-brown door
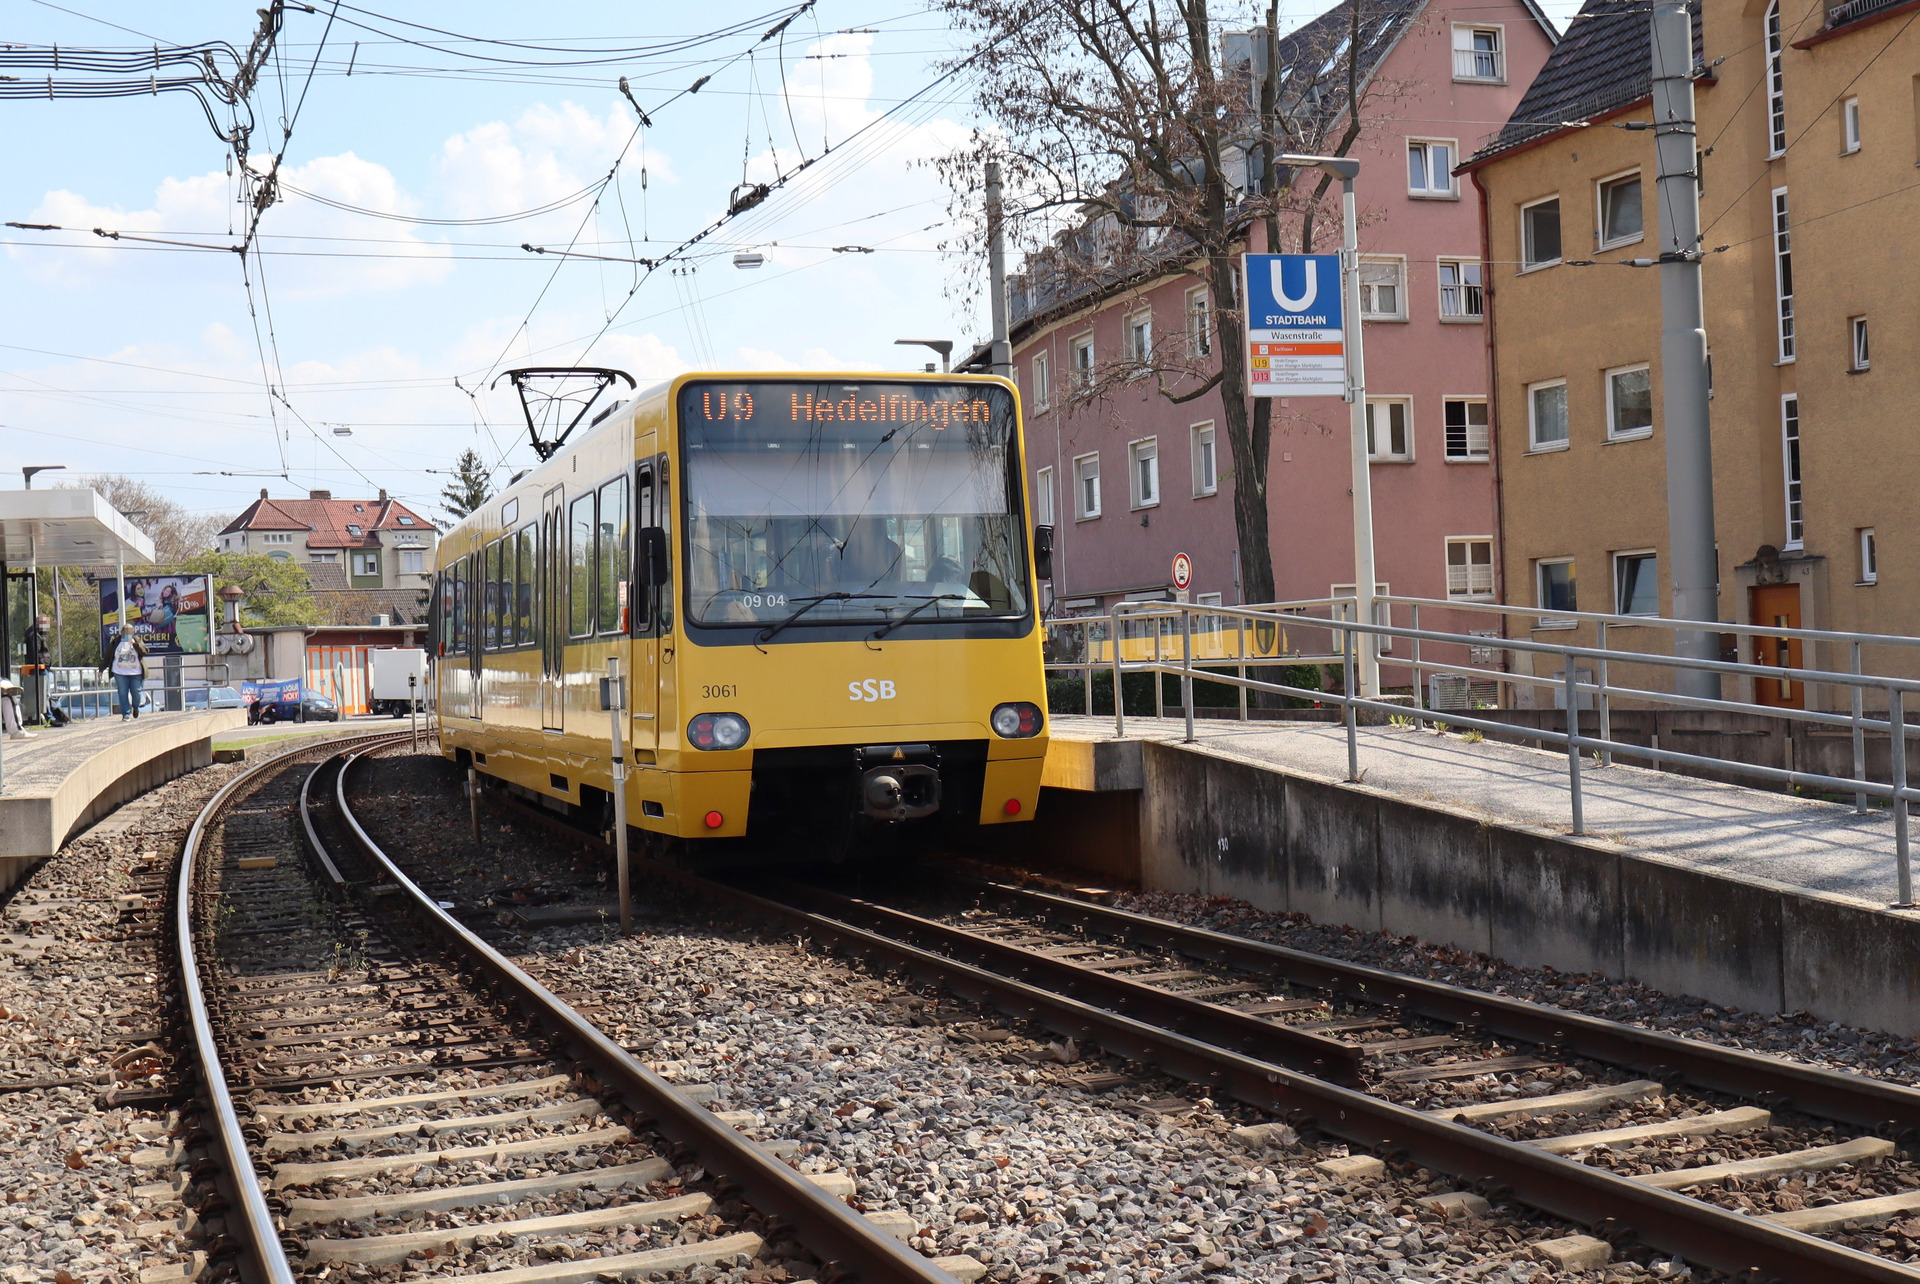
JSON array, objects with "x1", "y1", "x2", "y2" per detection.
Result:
[{"x1": 1461, "y1": 0, "x2": 1920, "y2": 706}]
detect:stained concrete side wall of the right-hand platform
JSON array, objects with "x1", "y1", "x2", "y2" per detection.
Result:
[{"x1": 1108, "y1": 741, "x2": 1920, "y2": 1034}]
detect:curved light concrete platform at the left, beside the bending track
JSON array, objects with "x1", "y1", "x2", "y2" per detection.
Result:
[{"x1": 0, "y1": 708, "x2": 246, "y2": 891}]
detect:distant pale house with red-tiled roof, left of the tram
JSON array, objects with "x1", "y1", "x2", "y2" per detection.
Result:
[{"x1": 219, "y1": 489, "x2": 440, "y2": 591}]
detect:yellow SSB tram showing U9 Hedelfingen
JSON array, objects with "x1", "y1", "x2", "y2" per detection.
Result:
[{"x1": 432, "y1": 374, "x2": 1052, "y2": 846}]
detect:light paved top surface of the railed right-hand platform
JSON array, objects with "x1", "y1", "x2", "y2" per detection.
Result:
[{"x1": 1054, "y1": 716, "x2": 1897, "y2": 904}]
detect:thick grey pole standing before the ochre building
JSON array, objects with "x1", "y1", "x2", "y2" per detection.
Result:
[{"x1": 1651, "y1": 0, "x2": 1720, "y2": 701}]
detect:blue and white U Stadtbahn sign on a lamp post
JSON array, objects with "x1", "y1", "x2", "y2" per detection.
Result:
[{"x1": 1244, "y1": 253, "x2": 1346, "y2": 397}]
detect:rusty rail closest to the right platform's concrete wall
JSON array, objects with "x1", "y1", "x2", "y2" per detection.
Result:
[{"x1": 960, "y1": 873, "x2": 1920, "y2": 1144}]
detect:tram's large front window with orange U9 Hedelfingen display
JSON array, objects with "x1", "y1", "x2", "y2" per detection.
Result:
[{"x1": 680, "y1": 380, "x2": 1027, "y2": 637}]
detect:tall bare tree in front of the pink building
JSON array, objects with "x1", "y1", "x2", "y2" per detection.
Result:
[{"x1": 937, "y1": 0, "x2": 1417, "y2": 603}]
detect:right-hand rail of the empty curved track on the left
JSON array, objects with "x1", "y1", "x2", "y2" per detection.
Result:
[{"x1": 338, "y1": 754, "x2": 967, "y2": 1284}]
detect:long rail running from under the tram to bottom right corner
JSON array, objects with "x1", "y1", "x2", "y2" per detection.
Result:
[{"x1": 641, "y1": 860, "x2": 1920, "y2": 1284}]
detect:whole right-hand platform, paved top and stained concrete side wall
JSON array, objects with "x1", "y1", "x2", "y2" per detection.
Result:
[{"x1": 1029, "y1": 716, "x2": 1920, "y2": 1036}]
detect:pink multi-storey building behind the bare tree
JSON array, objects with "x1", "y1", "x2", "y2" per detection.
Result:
[{"x1": 1010, "y1": 0, "x2": 1557, "y2": 614}]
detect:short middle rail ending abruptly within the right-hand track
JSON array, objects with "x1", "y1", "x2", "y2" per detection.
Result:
[{"x1": 774, "y1": 881, "x2": 1365, "y2": 1088}]
